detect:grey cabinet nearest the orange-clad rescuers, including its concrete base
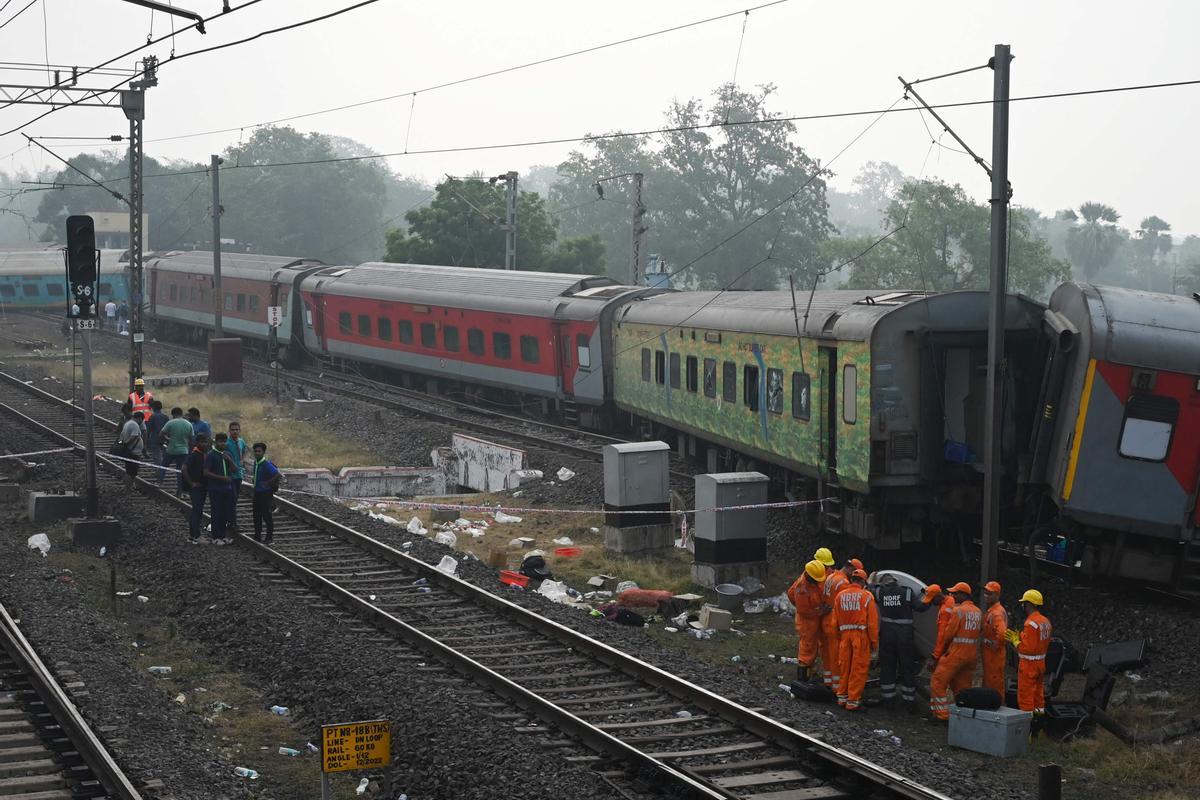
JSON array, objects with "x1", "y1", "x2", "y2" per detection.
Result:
[{"x1": 691, "y1": 473, "x2": 768, "y2": 589}]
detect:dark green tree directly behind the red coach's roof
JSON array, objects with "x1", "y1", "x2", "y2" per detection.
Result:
[{"x1": 384, "y1": 179, "x2": 604, "y2": 273}]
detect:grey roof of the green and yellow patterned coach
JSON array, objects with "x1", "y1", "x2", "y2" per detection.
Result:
[{"x1": 619, "y1": 289, "x2": 926, "y2": 341}]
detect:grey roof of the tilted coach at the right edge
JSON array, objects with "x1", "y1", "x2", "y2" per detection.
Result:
[{"x1": 1050, "y1": 283, "x2": 1200, "y2": 374}]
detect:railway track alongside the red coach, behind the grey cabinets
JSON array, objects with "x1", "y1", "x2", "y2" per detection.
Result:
[{"x1": 14, "y1": 314, "x2": 695, "y2": 485}]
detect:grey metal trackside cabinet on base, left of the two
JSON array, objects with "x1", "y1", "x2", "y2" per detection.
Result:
[{"x1": 604, "y1": 441, "x2": 674, "y2": 555}]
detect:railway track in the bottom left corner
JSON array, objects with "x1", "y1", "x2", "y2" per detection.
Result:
[{"x1": 0, "y1": 606, "x2": 142, "y2": 800}]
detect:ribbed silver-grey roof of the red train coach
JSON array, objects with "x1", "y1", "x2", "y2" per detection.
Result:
[{"x1": 322, "y1": 261, "x2": 626, "y2": 311}]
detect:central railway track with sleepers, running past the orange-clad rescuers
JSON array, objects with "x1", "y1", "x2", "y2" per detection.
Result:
[{"x1": 0, "y1": 373, "x2": 947, "y2": 800}]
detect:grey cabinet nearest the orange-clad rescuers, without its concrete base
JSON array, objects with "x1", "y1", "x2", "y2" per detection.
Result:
[{"x1": 695, "y1": 473, "x2": 768, "y2": 564}]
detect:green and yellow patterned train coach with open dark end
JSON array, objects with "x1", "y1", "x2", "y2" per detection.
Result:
[{"x1": 612, "y1": 290, "x2": 1044, "y2": 548}]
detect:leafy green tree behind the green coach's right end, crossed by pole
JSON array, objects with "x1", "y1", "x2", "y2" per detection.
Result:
[{"x1": 822, "y1": 180, "x2": 1070, "y2": 297}]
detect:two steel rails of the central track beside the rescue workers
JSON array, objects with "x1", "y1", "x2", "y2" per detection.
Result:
[{"x1": 0, "y1": 373, "x2": 950, "y2": 800}]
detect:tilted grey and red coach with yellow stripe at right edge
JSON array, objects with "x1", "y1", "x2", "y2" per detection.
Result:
[{"x1": 1030, "y1": 283, "x2": 1200, "y2": 596}]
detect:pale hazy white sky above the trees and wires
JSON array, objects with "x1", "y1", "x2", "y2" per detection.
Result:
[{"x1": 0, "y1": 0, "x2": 1200, "y2": 236}]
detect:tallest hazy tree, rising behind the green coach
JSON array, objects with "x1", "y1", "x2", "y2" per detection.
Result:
[{"x1": 552, "y1": 84, "x2": 833, "y2": 289}]
